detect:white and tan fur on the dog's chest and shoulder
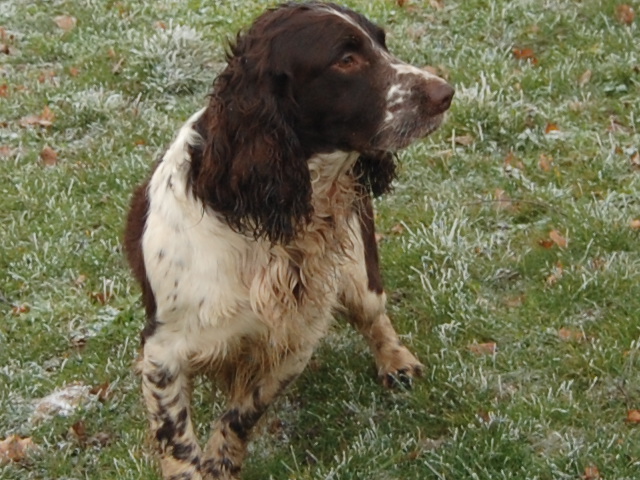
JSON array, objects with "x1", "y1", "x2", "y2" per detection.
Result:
[{"x1": 142, "y1": 111, "x2": 358, "y2": 368}]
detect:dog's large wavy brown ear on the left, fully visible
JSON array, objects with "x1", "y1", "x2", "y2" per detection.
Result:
[{"x1": 191, "y1": 37, "x2": 312, "y2": 243}]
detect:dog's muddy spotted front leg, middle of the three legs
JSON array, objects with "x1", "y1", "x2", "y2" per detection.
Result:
[{"x1": 202, "y1": 344, "x2": 313, "y2": 480}]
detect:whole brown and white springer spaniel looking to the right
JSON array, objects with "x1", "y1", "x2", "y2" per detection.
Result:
[{"x1": 125, "y1": 1, "x2": 454, "y2": 480}]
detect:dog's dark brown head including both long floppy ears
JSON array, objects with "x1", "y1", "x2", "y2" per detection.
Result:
[{"x1": 192, "y1": 2, "x2": 454, "y2": 242}]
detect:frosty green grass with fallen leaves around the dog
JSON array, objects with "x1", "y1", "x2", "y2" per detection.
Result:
[{"x1": 0, "y1": 0, "x2": 640, "y2": 480}]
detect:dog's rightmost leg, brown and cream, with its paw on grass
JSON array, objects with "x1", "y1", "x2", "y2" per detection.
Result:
[{"x1": 341, "y1": 197, "x2": 424, "y2": 387}]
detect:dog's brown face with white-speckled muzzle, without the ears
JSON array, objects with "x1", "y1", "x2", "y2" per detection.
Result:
[{"x1": 265, "y1": 1, "x2": 454, "y2": 153}]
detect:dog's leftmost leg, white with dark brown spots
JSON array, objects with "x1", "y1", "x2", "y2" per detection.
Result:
[{"x1": 140, "y1": 333, "x2": 202, "y2": 480}]
